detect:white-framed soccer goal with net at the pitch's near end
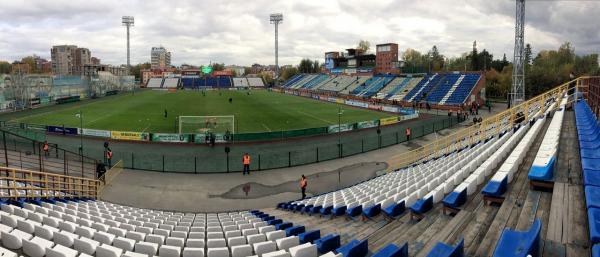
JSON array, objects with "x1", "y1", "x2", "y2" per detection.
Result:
[{"x1": 179, "y1": 115, "x2": 235, "y2": 134}]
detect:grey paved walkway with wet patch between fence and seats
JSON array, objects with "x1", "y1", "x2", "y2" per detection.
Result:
[{"x1": 101, "y1": 103, "x2": 503, "y2": 212}]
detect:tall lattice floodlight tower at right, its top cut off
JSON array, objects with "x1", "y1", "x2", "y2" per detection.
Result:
[{"x1": 510, "y1": 0, "x2": 525, "y2": 107}]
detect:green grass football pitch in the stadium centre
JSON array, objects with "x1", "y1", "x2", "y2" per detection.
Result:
[{"x1": 0, "y1": 90, "x2": 391, "y2": 133}]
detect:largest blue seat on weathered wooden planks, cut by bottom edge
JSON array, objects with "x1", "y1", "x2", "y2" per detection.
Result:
[{"x1": 494, "y1": 219, "x2": 542, "y2": 257}]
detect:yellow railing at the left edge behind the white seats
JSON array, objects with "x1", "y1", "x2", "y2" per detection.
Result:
[{"x1": 0, "y1": 167, "x2": 100, "y2": 200}]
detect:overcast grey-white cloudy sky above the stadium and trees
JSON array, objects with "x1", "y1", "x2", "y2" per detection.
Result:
[{"x1": 0, "y1": 0, "x2": 600, "y2": 65}]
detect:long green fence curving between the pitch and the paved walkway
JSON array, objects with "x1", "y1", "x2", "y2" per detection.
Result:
[{"x1": 104, "y1": 116, "x2": 458, "y2": 173}]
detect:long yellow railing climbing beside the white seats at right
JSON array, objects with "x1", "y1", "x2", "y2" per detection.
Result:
[{"x1": 388, "y1": 76, "x2": 597, "y2": 171}]
